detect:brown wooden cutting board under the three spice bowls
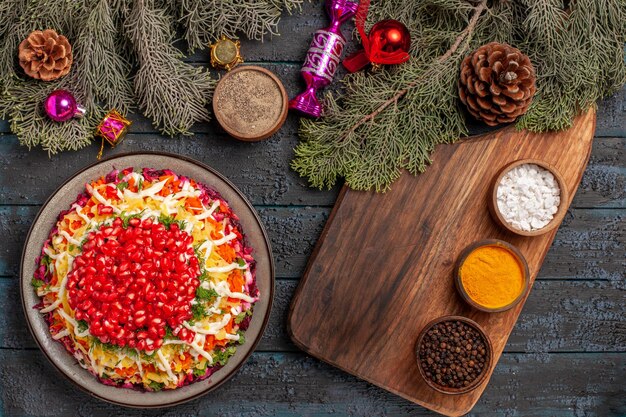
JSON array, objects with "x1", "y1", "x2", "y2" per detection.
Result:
[{"x1": 288, "y1": 110, "x2": 596, "y2": 416}]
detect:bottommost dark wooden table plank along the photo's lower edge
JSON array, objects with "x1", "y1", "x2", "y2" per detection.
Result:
[{"x1": 0, "y1": 350, "x2": 626, "y2": 417}]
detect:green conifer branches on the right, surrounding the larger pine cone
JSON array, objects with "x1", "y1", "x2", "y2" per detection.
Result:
[{"x1": 291, "y1": 0, "x2": 626, "y2": 192}]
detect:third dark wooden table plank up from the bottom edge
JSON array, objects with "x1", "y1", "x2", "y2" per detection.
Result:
[{"x1": 0, "y1": 206, "x2": 626, "y2": 281}]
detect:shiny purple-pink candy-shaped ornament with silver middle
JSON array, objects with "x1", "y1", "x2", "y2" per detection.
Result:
[{"x1": 289, "y1": 0, "x2": 359, "y2": 117}]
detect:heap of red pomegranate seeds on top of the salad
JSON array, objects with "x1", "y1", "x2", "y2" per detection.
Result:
[{"x1": 67, "y1": 218, "x2": 200, "y2": 350}]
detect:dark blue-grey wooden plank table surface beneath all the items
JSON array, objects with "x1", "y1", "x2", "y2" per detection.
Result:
[{"x1": 0, "y1": 4, "x2": 626, "y2": 417}]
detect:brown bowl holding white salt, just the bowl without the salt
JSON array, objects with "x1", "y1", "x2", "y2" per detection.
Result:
[{"x1": 488, "y1": 159, "x2": 569, "y2": 236}]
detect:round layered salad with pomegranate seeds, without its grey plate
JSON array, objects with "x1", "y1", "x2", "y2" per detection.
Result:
[{"x1": 32, "y1": 168, "x2": 260, "y2": 391}]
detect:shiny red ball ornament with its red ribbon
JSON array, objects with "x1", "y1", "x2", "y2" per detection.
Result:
[{"x1": 343, "y1": 0, "x2": 411, "y2": 72}]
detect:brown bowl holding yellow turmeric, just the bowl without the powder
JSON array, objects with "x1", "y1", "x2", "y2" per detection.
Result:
[{"x1": 454, "y1": 239, "x2": 530, "y2": 313}]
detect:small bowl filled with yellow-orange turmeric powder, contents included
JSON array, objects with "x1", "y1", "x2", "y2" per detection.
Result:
[{"x1": 455, "y1": 239, "x2": 530, "y2": 313}]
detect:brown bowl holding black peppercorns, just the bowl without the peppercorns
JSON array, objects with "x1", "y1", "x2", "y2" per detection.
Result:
[{"x1": 415, "y1": 316, "x2": 493, "y2": 395}]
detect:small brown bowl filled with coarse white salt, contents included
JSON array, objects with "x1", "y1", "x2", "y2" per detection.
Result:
[{"x1": 488, "y1": 159, "x2": 569, "y2": 236}]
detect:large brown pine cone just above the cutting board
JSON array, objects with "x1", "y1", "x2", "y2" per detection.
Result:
[{"x1": 459, "y1": 42, "x2": 537, "y2": 126}]
